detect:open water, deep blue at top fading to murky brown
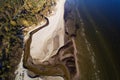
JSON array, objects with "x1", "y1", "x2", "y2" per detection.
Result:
[{"x1": 70, "y1": 0, "x2": 120, "y2": 80}]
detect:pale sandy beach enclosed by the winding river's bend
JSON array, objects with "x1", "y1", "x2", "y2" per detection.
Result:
[{"x1": 30, "y1": 0, "x2": 65, "y2": 63}]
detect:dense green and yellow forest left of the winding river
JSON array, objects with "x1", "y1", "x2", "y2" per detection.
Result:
[{"x1": 0, "y1": 0, "x2": 56, "y2": 80}]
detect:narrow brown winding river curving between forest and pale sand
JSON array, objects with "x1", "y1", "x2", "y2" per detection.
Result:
[{"x1": 16, "y1": 0, "x2": 70, "y2": 80}]
